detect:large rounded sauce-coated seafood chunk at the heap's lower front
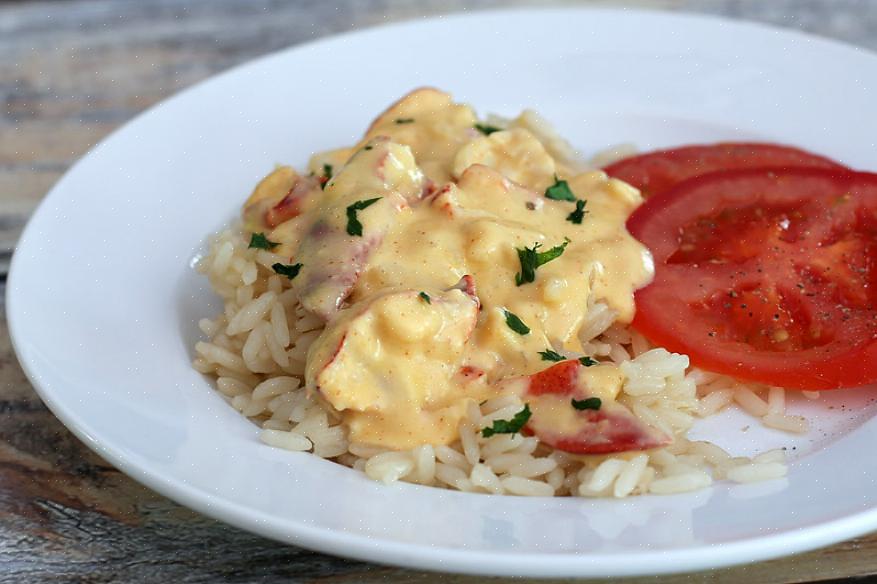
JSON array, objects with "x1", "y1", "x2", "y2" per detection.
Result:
[{"x1": 306, "y1": 289, "x2": 478, "y2": 447}]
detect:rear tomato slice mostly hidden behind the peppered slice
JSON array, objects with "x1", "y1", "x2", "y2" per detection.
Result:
[{"x1": 604, "y1": 142, "x2": 846, "y2": 198}]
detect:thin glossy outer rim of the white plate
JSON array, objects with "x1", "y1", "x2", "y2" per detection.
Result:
[{"x1": 6, "y1": 7, "x2": 877, "y2": 577}]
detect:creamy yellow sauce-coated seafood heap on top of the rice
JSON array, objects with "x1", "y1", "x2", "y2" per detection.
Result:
[{"x1": 245, "y1": 89, "x2": 652, "y2": 449}]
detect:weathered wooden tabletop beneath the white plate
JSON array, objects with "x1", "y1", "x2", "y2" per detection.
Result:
[{"x1": 0, "y1": 0, "x2": 877, "y2": 583}]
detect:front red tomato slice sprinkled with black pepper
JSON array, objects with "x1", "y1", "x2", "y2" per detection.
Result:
[{"x1": 627, "y1": 168, "x2": 877, "y2": 390}]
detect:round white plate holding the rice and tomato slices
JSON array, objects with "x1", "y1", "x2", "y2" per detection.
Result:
[{"x1": 8, "y1": 10, "x2": 877, "y2": 576}]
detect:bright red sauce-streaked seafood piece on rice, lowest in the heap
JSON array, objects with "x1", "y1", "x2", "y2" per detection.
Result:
[{"x1": 526, "y1": 361, "x2": 672, "y2": 454}]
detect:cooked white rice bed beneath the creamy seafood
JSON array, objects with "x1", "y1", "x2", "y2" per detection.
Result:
[{"x1": 193, "y1": 230, "x2": 818, "y2": 497}]
